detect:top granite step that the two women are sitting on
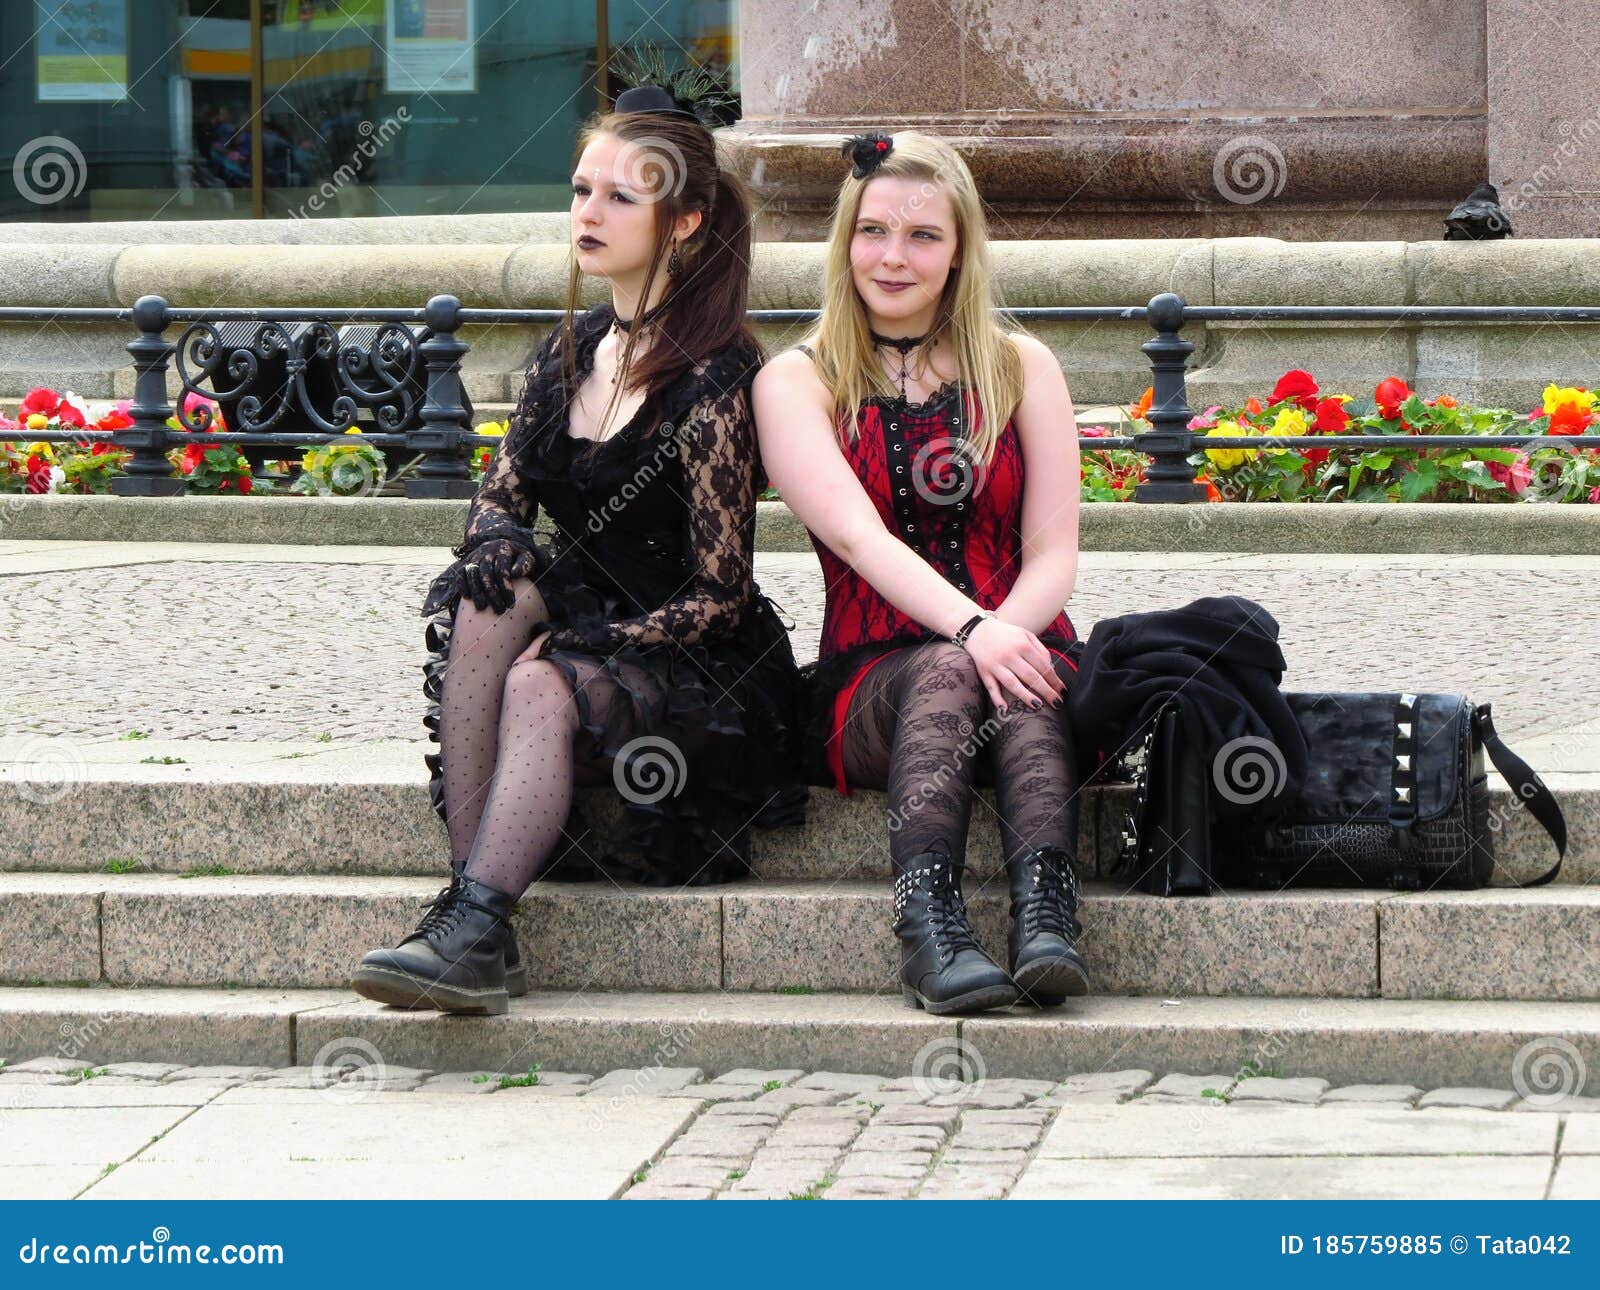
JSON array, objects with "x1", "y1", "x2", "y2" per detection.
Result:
[{"x1": 0, "y1": 771, "x2": 1580, "y2": 885}]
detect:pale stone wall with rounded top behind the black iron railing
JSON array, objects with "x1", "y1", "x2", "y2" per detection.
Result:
[{"x1": 0, "y1": 226, "x2": 1600, "y2": 408}]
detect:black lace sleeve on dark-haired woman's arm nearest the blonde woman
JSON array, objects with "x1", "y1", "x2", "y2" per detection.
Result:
[{"x1": 549, "y1": 374, "x2": 757, "y2": 651}]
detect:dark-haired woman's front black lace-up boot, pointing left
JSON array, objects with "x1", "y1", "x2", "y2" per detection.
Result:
[{"x1": 350, "y1": 875, "x2": 526, "y2": 1016}]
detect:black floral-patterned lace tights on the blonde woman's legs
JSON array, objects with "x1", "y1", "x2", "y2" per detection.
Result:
[{"x1": 843, "y1": 640, "x2": 1078, "y2": 871}]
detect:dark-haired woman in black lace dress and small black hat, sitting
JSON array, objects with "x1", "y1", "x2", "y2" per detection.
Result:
[{"x1": 352, "y1": 86, "x2": 806, "y2": 1013}]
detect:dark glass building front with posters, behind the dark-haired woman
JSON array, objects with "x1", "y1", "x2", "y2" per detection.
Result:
[{"x1": 0, "y1": 0, "x2": 738, "y2": 221}]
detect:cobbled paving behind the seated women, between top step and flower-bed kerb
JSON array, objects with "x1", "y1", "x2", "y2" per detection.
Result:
[{"x1": 0, "y1": 543, "x2": 1600, "y2": 743}]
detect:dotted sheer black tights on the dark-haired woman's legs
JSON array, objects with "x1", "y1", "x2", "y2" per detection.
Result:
[{"x1": 438, "y1": 578, "x2": 618, "y2": 896}]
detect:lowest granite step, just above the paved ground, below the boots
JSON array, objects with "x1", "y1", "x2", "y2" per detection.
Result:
[{"x1": 0, "y1": 986, "x2": 1600, "y2": 1088}]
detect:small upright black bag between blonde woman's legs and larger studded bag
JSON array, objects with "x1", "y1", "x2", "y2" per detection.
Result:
[{"x1": 1110, "y1": 698, "x2": 1216, "y2": 896}]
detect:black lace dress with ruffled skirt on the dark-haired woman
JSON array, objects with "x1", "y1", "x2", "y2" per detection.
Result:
[{"x1": 422, "y1": 306, "x2": 808, "y2": 887}]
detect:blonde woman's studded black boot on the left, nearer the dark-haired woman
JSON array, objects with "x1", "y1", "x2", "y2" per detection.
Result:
[{"x1": 894, "y1": 847, "x2": 1018, "y2": 1015}]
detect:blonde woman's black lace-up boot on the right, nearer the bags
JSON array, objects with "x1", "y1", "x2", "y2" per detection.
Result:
[{"x1": 1006, "y1": 847, "x2": 1090, "y2": 1008}]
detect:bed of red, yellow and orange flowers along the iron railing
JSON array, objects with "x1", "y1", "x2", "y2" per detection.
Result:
[{"x1": 15, "y1": 368, "x2": 1600, "y2": 503}]
